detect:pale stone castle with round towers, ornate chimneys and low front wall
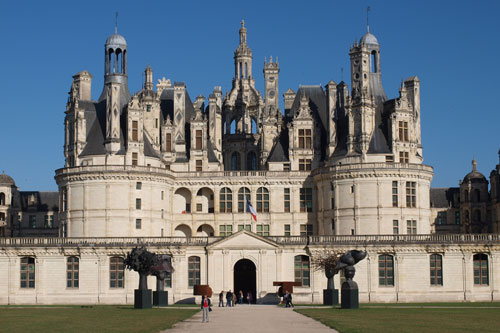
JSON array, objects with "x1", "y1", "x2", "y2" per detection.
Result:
[{"x1": 0, "y1": 22, "x2": 500, "y2": 304}]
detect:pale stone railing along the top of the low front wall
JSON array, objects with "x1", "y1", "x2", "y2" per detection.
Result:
[{"x1": 0, "y1": 234, "x2": 500, "y2": 247}]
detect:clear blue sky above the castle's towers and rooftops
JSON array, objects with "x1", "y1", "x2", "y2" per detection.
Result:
[{"x1": 0, "y1": 0, "x2": 500, "y2": 190}]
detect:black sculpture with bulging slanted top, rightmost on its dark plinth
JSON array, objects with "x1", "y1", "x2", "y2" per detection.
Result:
[{"x1": 335, "y1": 250, "x2": 366, "y2": 309}]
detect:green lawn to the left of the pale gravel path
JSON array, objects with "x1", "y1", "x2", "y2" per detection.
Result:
[{"x1": 0, "y1": 306, "x2": 199, "y2": 332}]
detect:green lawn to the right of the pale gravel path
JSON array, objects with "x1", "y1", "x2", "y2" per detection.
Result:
[{"x1": 295, "y1": 303, "x2": 500, "y2": 333}]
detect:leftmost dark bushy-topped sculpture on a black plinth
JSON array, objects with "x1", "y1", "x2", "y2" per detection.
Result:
[{"x1": 124, "y1": 246, "x2": 159, "y2": 309}]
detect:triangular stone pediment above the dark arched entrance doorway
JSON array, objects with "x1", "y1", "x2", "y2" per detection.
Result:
[{"x1": 207, "y1": 230, "x2": 279, "y2": 250}]
